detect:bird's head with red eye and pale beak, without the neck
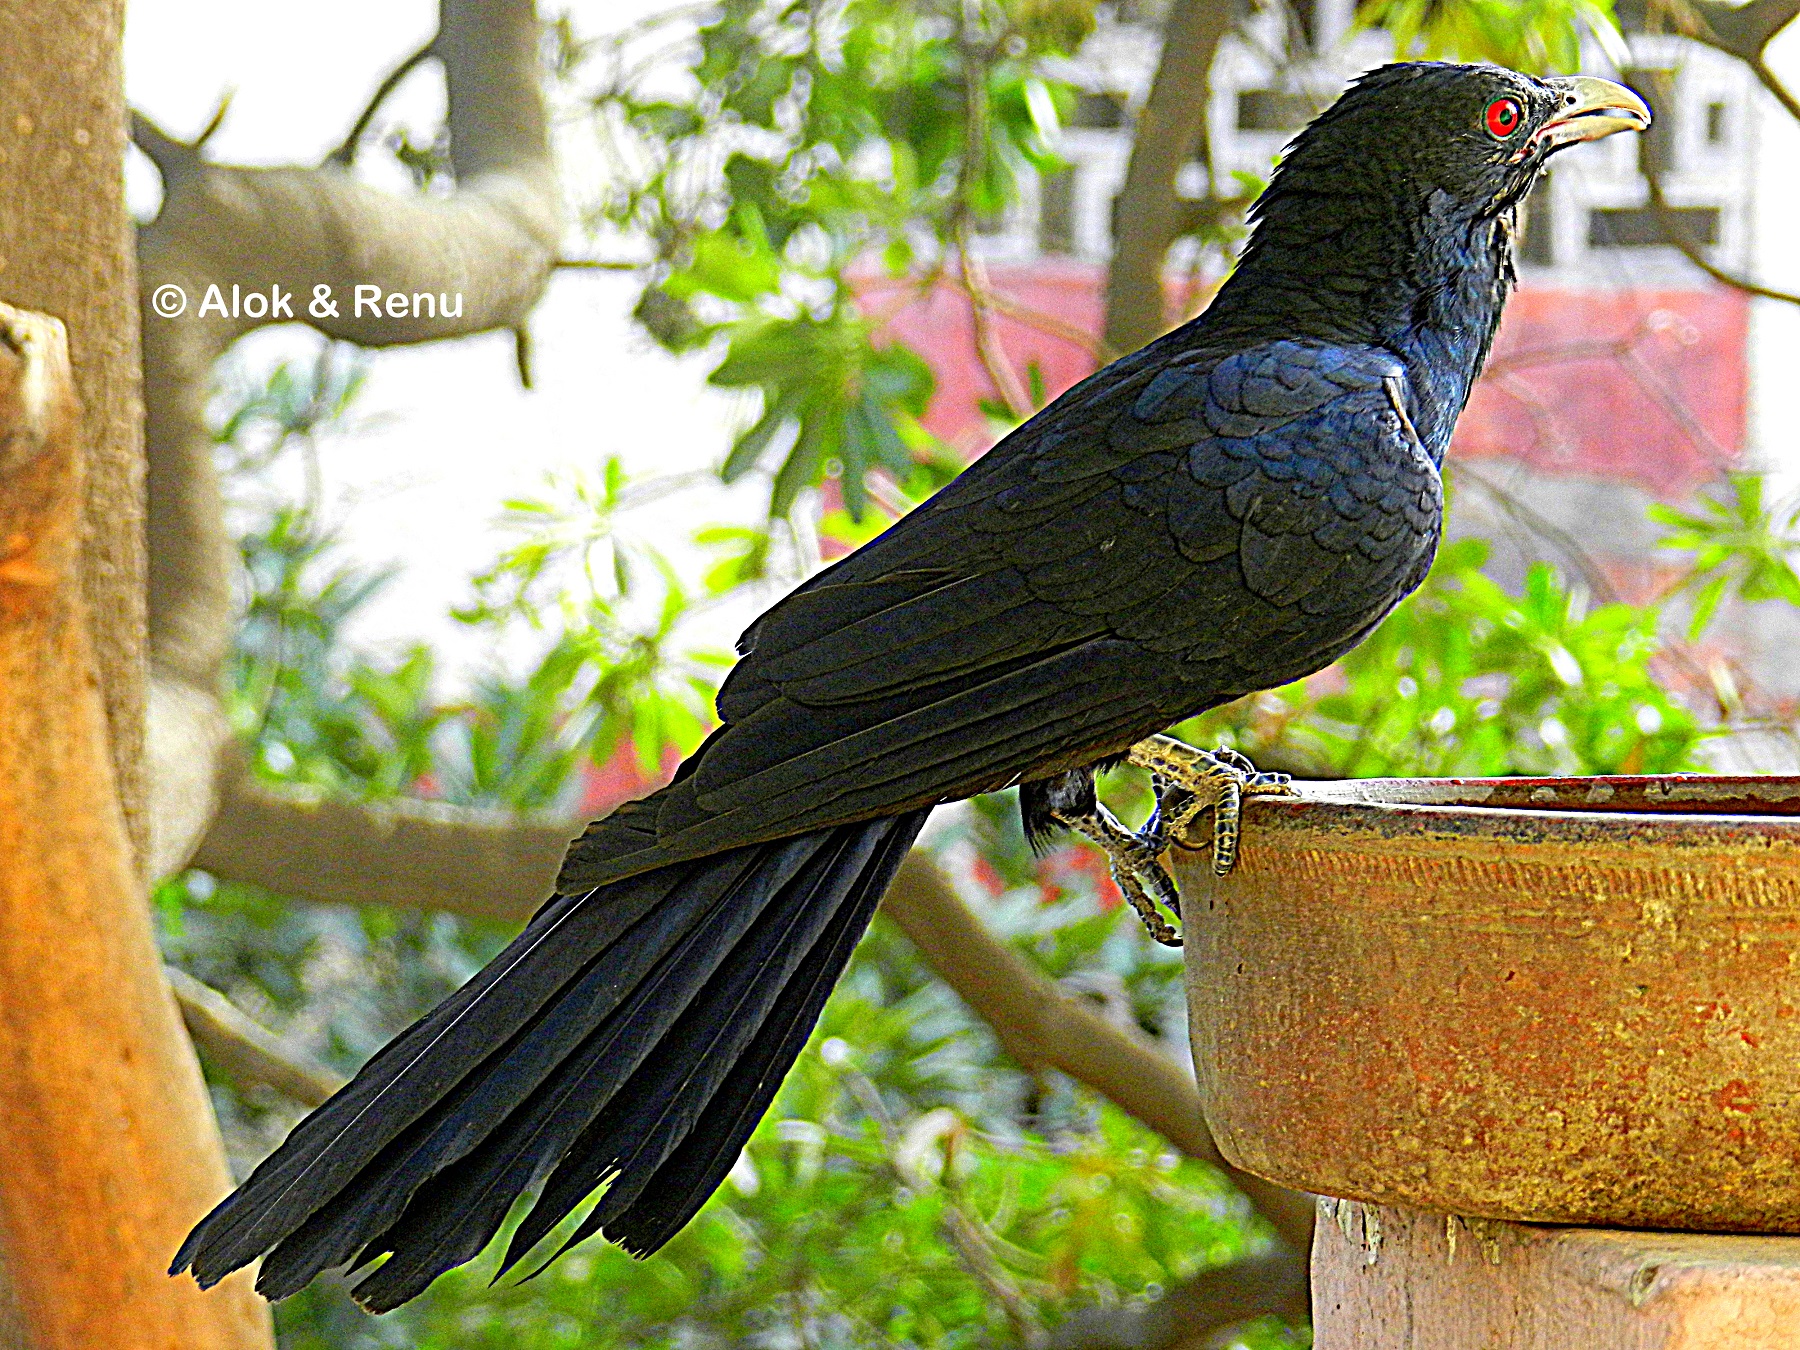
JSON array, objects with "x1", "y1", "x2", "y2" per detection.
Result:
[{"x1": 1271, "y1": 61, "x2": 1651, "y2": 216}]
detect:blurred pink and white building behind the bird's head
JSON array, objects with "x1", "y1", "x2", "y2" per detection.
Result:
[{"x1": 871, "y1": 0, "x2": 1760, "y2": 594}]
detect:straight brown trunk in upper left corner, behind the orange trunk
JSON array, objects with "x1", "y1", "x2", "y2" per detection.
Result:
[{"x1": 0, "y1": 0, "x2": 148, "y2": 859}]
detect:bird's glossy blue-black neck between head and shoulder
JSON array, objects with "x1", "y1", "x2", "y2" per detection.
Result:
[{"x1": 1197, "y1": 193, "x2": 1514, "y2": 459}]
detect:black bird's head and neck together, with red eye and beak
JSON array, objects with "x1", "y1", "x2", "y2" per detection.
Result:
[{"x1": 1206, "y1": 61, "x2": 1651, "y2": 360}]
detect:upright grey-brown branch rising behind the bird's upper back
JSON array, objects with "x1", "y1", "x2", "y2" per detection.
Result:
[{"x1": 1103, "y1": 0, "x2": 1235, "y2": 351}]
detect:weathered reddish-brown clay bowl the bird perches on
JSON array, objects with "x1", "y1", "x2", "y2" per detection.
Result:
[{"x1": 1175, "y1": 778, "x2": 1800, "y2": 1233}]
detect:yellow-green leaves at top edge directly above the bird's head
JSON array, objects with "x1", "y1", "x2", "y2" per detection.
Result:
[{"x1": 1357, "y1": 0, "x2": 1625, "y2": 74}]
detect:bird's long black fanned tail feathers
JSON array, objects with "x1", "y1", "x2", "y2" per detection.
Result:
[{"x1": 171, "y1": 810, "x2": 927, "y2": 1312}]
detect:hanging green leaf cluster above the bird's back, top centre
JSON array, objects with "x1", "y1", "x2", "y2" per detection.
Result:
[{"x1": 592, "y1": 0, "x2": 1093, "y2": 520}]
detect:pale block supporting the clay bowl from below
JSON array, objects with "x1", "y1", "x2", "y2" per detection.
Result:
[{"x1": 1312, "y1": 1201, "x2": 1800, "y2": 1350}]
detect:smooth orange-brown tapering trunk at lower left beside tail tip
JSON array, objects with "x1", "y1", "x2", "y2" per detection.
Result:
[{"x1": 0, "y1": 306, "x2": 270, "y2": 1350}]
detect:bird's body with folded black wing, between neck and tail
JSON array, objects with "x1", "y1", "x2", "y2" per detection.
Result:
[{"x1": 560, "y1": 333, "x2": 1442, "y2": 889}]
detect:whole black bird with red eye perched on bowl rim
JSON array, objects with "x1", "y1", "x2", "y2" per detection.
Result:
[{"x1": 173, "y1": 63, "x2": 1649, "y2": 1310}]
